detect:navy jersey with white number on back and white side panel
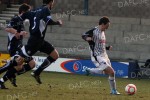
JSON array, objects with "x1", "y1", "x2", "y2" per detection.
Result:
[{"x1": 20, "y1": 6, "x2": 59, "y2": 39}]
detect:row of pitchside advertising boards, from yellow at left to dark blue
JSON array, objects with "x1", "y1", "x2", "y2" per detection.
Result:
[{"x1": 0, "y1": 54, "x2": 134, "y2": 78}]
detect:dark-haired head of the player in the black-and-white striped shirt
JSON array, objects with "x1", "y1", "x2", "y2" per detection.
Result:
[{"x1": 99, "y1": 16, "x2": 110, "y2": 31}]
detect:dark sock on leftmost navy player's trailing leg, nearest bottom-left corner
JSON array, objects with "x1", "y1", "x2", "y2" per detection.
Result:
[{"x1": 0, "y1": 68, "x2": 17, "y2": 82}]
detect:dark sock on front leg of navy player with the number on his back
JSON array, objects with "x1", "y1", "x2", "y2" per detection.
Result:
[{"x1": 34, "y1": 56, "x2": 55, "y2": 75}]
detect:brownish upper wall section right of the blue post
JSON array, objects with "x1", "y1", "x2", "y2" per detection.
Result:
[{"x1": 89, "y1": 0, "x2": 150, "y2": 18}]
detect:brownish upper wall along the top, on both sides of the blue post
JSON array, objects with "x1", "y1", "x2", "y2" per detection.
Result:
[{"x1": 41, "y1": 0, "x2": 150, "y2": 18}]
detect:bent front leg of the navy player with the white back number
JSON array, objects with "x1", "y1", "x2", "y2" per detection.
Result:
[{"x1": 31, "y1": 41, "x2": 59, "y2": 84}]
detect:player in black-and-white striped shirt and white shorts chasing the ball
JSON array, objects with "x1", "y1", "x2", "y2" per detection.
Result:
[{"x1": 82, "y1": 16, "x2": 120, "y2": 95}]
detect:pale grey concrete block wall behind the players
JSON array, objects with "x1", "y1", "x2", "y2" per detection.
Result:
[{"x1": 0, "y1": 14, "x2": 150, "y2": 61}]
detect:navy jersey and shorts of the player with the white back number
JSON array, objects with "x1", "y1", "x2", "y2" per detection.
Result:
[{"x1": 18, "y1": 6, "x2": 60, "y2": 57}]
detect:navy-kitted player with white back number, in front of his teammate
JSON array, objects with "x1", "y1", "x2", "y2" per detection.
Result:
[{"x1": 0, "y1": 0, "x2": 62, "y2": 84}]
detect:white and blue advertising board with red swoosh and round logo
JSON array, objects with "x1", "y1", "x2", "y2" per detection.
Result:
[{"x1": 33, "y1": 56, "x2": 129, "y2": 78}]
